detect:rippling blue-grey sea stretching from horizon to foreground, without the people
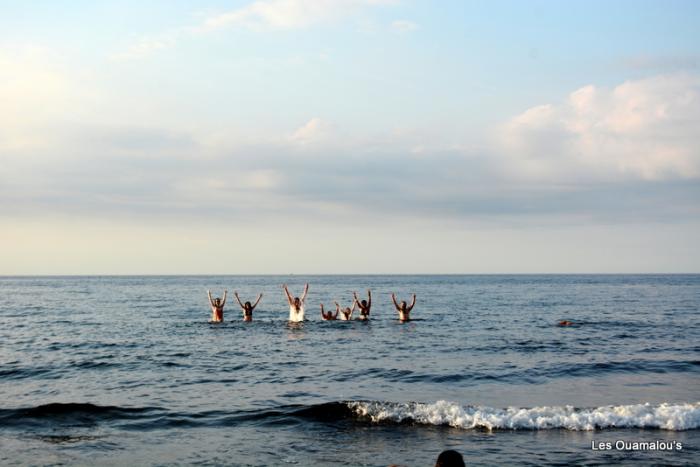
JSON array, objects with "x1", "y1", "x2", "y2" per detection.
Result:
[{"x1": 0, "y1": 275, "x2": 700, "y2": 466}]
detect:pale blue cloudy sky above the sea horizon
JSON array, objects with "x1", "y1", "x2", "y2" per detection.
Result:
[{"x1": 0, "y1": 0, "x2": 700, "y2": 275}]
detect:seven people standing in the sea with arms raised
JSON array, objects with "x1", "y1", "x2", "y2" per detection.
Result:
[{"x1": 207, "y1": 284, "x2": 416, "y2": 323}]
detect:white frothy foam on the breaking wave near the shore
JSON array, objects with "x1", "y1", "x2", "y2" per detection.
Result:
[{"x1": 348, "y1": 401, "x2": 700, "y2": 431}]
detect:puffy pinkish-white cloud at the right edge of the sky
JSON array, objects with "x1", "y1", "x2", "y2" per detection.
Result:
[{"x1": 500, "y1": 74, "x2": 700, "y2": 180}]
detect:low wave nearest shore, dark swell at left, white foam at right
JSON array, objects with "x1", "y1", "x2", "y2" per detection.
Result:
[{"x1": 0, "y1": 401, "x2": 700, "y2": 431}]
